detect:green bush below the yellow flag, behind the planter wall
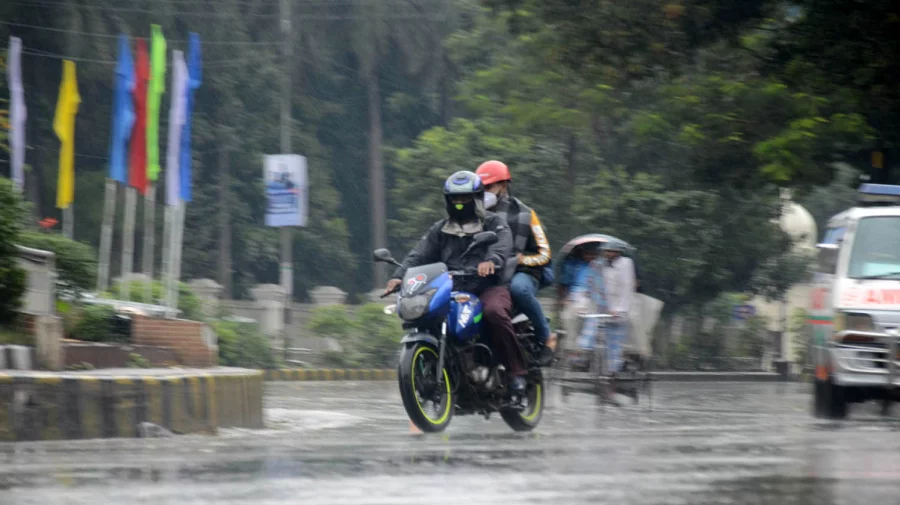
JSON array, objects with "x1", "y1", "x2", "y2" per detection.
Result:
[{"x1": 19, "y1": 231, "x2": 97, "y2": 291}]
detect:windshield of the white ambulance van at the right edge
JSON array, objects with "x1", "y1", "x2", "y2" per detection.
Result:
[{"x1": 848, "y1": 216, "x2": 900, "y2": 279}]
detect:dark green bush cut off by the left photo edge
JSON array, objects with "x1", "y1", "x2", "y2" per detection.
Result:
[{"x1": 0, "y1": 179, "x2": 26, "y2": 324}]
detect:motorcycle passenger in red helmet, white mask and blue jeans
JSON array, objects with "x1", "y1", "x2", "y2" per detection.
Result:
[{"x1": 475, "y1": 160, "x2": 555, "y2": 363}]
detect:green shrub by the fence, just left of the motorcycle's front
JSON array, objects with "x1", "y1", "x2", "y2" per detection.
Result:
[{"x1": 310, "y1": 303, "x2": 401, "y2": 368}]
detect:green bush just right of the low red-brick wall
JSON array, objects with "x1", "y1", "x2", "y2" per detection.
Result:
[{"x1": 212, "y1": 321, "x2": 278, "y2": 369}]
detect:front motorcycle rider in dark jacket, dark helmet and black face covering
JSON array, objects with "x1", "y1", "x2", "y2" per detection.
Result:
[{"x1": 385, "y1": 171, "x2": 527, "y2": 392}]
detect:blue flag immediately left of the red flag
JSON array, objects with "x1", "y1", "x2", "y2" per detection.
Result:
[{"x1": 109, "y1": 34, "x2": 135, "y2": 184}]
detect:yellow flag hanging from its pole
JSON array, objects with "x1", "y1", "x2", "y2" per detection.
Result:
[{"x1": 53, "y1": 60, "x2": 81, "y2": 209}]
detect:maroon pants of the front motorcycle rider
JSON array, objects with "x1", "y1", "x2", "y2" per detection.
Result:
[{"x1": 479, "y1": 286, "x2": 528, "y2": 377}]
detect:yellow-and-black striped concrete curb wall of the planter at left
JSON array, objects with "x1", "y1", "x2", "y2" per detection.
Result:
[{"x1": 0, "y1": 370, "x2": 263, "y2": 442}]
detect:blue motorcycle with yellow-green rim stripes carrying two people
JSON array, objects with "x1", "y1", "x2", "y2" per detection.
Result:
[{"x1": 374, "y1": 232, "x2": 544, "y2": 433}]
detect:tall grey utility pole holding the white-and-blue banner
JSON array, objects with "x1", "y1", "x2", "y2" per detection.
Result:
[{"x1": 279, "y1": 0, "x2": 294, "y2": 359}]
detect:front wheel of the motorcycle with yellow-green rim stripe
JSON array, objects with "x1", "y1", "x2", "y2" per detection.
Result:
[{"x1": 397, "y1": 342, "x2": 454, "y2": 433}]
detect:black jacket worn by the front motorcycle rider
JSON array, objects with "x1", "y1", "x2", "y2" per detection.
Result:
[{"x1": 392, "y1": 212, "x2": 514, "y2": 291}]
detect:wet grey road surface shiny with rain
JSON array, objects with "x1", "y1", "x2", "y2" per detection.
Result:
[{"x1": 0, "y1": 382, "x2": 900, "y2": 505}]
